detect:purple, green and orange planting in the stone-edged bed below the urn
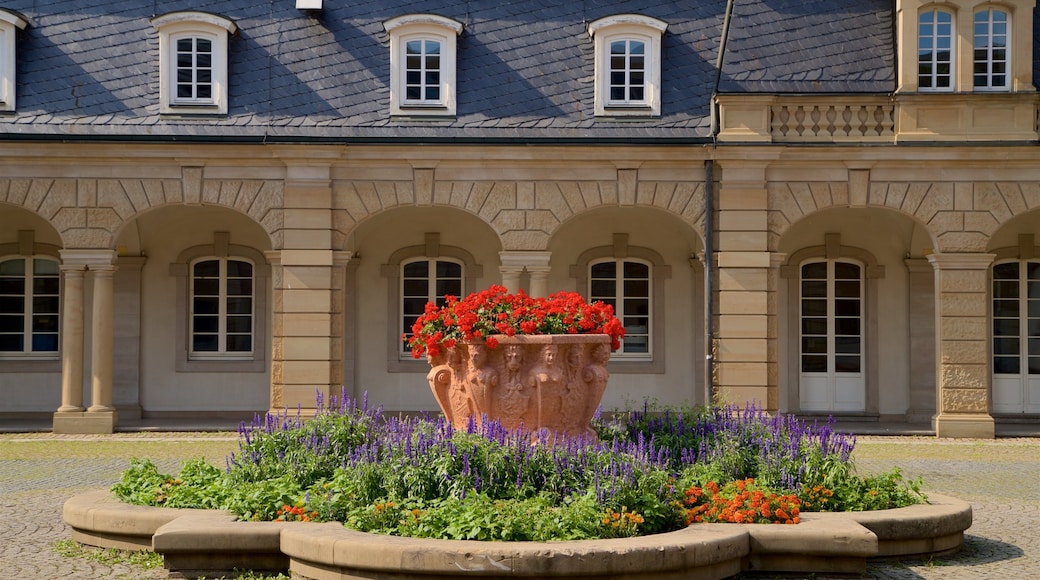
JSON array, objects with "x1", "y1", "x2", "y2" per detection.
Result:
[{"x1": 112, "y1": 397, "x2": 922, "y2": 541}]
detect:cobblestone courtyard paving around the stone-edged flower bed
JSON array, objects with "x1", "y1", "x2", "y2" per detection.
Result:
[{"x1": 0, "y1": 433, "x2": 1040, "y2": 580}]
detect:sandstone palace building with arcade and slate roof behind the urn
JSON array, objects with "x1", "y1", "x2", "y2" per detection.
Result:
[{"x1": 0, "y1": 0, "x2": 1040, "y2": 437}]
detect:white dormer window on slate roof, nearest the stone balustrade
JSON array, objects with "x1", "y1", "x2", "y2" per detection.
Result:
[{"x1": 589, "y1": 15, "x2": 668, "y2": 116}]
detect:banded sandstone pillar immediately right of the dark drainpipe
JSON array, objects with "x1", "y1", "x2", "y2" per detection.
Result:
[{"x1": 716, "y1": 161, "x2": 779, "y2": 412}]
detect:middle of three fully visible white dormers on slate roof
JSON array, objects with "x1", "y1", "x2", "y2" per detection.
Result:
[{"x1": 383, "y1": 15, "x2": 463, "y2": 115}]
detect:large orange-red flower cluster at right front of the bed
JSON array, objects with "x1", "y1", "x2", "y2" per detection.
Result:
[{"x1": 685, "y1": 478, "x2": 802, "y2": 525}]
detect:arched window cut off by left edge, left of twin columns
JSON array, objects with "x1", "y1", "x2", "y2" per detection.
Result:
[{"x1": 0, "y1": 256, "x2": 61, "y2": 358}]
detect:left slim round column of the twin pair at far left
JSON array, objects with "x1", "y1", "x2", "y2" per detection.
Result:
[{"x1": 54, "y1": 265, "x2": 85, "y2": 413}]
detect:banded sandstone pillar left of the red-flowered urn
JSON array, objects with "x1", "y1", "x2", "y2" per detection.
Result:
[{"x1": 267, "y1": 165, "x2": 334, "y2": 416}]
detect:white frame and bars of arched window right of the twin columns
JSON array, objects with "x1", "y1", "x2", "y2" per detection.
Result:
[{"x1": 188, "y1": 256, "x2": 257, "y2": 361}]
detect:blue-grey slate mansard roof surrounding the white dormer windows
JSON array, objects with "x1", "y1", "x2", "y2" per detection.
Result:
[{"x1": 0, "y1": 0, "x2": 973, "y2": 141}]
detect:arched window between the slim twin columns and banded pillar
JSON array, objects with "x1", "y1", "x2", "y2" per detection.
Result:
[{"x1": 188, "y1": 257, "x2": 256, "y2": 360}]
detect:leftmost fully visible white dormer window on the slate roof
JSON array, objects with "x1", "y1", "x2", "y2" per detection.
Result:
[{"x1": 152, "y1": 11, "x2": 238, "y2": 114}]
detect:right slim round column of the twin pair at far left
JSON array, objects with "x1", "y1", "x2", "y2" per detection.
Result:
[{"x1": 86, "y1": 265, "x2": 115, "y2": 415}]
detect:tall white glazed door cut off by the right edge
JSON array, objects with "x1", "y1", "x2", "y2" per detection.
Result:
[{"x1": 992, "y1": 260, "x2": 1040, "y2": 413}]
